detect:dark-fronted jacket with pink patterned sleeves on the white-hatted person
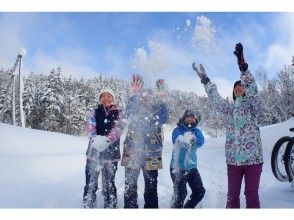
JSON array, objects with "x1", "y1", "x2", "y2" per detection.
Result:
[{"x1": 86, "y1": 105, "x2": 123, "y2": 161}]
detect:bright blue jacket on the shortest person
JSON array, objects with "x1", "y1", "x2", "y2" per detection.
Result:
[{"x1": 170, "y1": 119, "x2": 204, "y2": 170}]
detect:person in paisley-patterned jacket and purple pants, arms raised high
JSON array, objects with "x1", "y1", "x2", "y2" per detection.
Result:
[{"x1": 192, "y1": 43, "x2": 263, "y2": 208}]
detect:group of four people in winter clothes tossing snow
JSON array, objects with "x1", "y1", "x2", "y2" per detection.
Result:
[{"x1": 83, "y1": 43, "x2": 263, "y2": 208}]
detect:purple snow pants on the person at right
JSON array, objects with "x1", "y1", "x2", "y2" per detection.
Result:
[{"x1": 227, "y1": 163, "x2": 262, "y2": 208}]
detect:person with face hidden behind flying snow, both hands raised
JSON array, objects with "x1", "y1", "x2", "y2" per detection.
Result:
[{"x1": 121, "y1": 75, "x2": 168, "y2": 208}]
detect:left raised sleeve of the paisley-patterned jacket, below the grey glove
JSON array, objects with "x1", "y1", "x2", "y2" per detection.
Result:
[{"x1": 204, "y1": 82, "x2": 231, "y2": 116}]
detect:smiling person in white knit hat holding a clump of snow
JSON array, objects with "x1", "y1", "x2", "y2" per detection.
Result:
[{"x1": 83, "y1": 88, "x2": 123, "y2": 208}]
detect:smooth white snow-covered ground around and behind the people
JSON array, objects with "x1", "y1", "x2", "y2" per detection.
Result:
[{"x1": 0, "y1": 118, "x2": 294, "y2": 208}]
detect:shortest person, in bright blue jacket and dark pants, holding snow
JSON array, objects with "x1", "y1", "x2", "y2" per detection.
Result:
[{"x1": 170, "y1": 110, "x2": 205, "y2": 208}]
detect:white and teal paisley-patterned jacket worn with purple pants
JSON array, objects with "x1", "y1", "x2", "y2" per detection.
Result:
[{"x1": 205, "y1": 71, "x2": 263, "y2": 166}]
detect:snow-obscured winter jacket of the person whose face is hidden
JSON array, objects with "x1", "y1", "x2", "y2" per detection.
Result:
[{"x1": 122, "y1": 95, "x2": 168, "y2": 169}]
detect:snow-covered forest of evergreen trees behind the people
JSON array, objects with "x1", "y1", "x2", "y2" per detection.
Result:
[{"x1": 0, "y1": 57, "x2": 294, "y2": 137}]
